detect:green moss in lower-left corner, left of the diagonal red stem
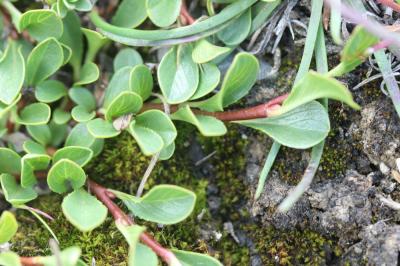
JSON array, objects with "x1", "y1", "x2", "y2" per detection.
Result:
[{"x1": 12, "y1": 193, "x2": 128, "y2": 265}]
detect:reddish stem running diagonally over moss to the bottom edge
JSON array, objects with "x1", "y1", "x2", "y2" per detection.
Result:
[{"x1": 88, "y1": 180, "x2": 177, "y2": 264}]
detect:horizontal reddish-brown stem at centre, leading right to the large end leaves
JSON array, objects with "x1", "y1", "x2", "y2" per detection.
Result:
[{"x1": 141, "y1": 94, "x2": 288, "y2": 121}]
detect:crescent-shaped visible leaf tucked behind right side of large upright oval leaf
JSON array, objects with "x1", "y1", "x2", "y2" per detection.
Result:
[{"x1": 190, "y1": 63, "x2": 221, "y2": 100}]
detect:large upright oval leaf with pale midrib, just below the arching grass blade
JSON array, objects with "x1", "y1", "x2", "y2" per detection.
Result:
[{"x1": 157, "y1": 44, "x2": 199, "y2": 104}]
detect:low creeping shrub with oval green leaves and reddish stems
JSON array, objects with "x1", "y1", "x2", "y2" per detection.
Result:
[{"x1": 0, "y1": 0, "x2": 384, "y2": 266}]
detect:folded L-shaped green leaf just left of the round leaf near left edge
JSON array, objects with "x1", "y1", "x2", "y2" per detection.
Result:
[{"x1": 21, "y1": 154, "x2": 51, "y2": 188}]
